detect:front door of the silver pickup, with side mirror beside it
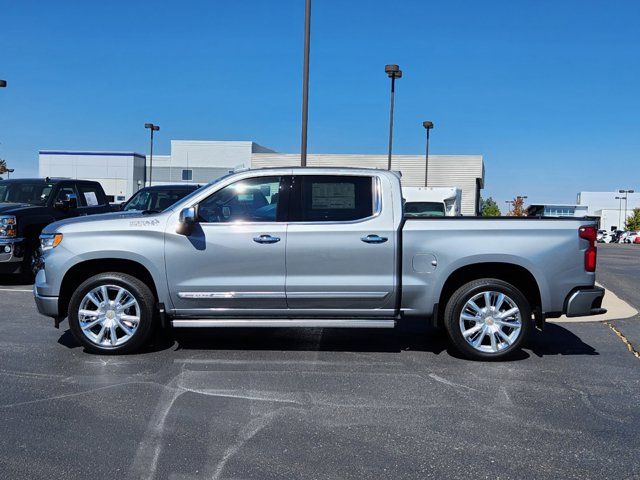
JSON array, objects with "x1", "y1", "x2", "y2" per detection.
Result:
[{"x1": 165, "y1": 176, "x2": 286, "y2": 317}]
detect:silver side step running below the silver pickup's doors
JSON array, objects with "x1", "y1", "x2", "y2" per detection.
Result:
[{"x1": 171, "y1": 318, "x2": 396, "y2": 328}]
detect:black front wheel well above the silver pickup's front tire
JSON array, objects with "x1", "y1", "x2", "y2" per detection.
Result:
[{"x1": 58, "y1": 258, "x2": 158, "y2": 318}]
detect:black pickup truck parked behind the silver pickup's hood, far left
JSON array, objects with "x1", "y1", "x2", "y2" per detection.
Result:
[{"x1": 0, "y1": 178, "x2": 111, "y2": 276}]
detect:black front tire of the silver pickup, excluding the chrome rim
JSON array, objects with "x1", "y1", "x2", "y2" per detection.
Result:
[{"x1": 69, "y1": 272, "x2": 156, "y2": 355}]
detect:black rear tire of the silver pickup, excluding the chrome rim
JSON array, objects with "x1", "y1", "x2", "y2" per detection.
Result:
[{"x1": 444, "y1": 278, "x2": 532, "y2": 360}]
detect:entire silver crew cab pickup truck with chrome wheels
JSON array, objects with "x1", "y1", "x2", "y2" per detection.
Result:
[{"x1": 34, "y1": 168, "x2": 604, "y2": 359}]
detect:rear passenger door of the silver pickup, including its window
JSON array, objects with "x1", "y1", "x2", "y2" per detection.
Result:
[{"x1": 286, "y1": 173, "x2": 397, "y2": 317}]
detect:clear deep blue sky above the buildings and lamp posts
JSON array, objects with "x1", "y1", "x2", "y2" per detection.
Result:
[{"x1": 0, "y1": 0, "x2": 640, "y2": 207}]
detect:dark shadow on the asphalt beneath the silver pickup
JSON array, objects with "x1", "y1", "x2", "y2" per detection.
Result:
[{"x1": 58, "y1": 324, "x2": 598, "y2": 361}]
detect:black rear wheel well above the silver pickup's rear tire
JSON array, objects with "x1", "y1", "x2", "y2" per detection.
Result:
[{"x1": 437, "y1": 262, "x2": 542, "y2": 326}]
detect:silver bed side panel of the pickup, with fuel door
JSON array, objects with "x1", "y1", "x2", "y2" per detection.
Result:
[{"x1": 401, "y1": 218, "x2": 595, "y2": 316}]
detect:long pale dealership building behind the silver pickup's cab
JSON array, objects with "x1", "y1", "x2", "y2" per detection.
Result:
[{"x1": 40, "y1": 140, "x2": 484, "y2": 215}]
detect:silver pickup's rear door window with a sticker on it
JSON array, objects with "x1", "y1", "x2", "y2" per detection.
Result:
[{"x1": 289, "y1": 175, "x2": 373, "y2": 222}]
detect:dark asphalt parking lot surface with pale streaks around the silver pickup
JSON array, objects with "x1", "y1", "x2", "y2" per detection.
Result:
[{"x1": 0, "y1": 245, "x2": 640, "y2": 479}]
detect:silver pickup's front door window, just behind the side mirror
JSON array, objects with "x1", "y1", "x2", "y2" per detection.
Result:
[{"x1": 198, "y1": 177, "x2": 280, "y2": 223}]
